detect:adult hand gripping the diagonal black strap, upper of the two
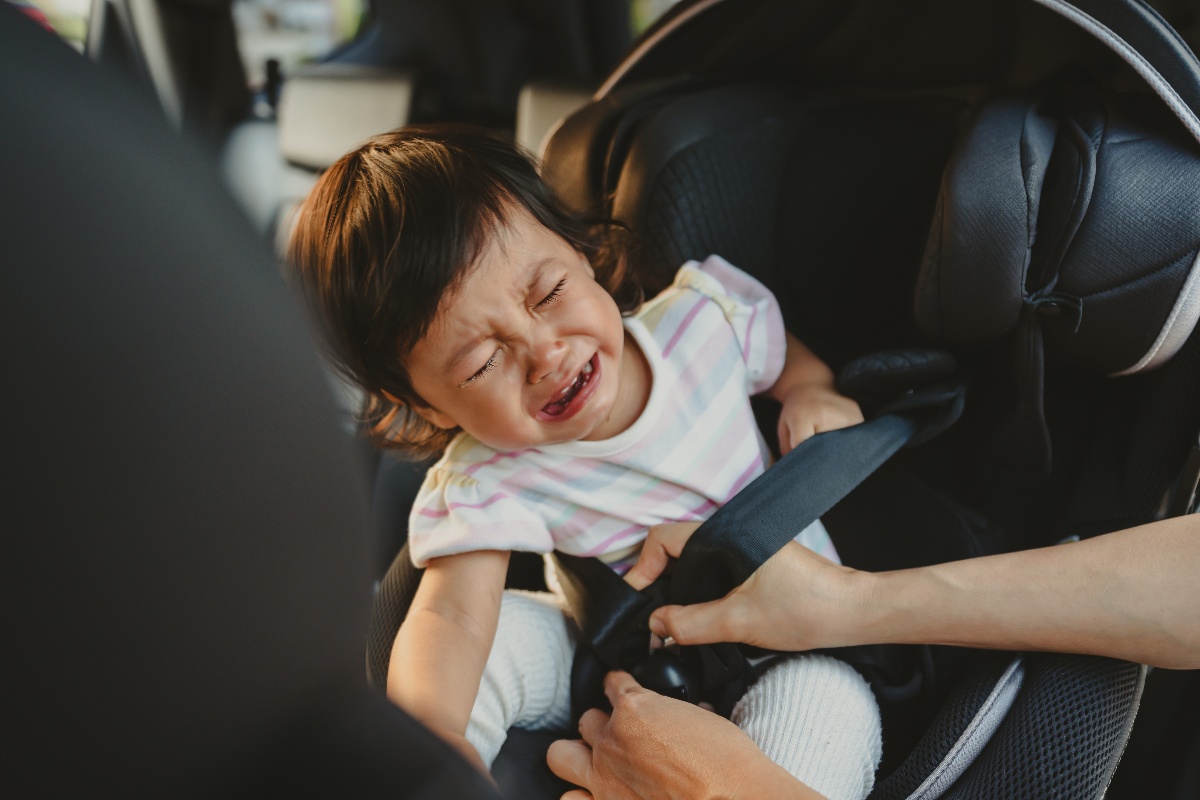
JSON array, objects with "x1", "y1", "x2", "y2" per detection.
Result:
[{"x1": 625, "y1": 523, "x2": 870, "y2": 650}]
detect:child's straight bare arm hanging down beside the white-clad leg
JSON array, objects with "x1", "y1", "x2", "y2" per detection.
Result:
[{"x1": 388, "y1": 551, "x2": 509, "y2": 772}]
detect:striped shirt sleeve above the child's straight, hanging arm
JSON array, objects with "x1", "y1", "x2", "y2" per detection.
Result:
[{"x1": 408, "y1": 465, "x2": 554, "y2": 567}]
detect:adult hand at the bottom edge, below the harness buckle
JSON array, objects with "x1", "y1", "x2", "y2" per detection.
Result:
[{"x1": 546, "y1": 672, "x2": 820, "y2": 800}]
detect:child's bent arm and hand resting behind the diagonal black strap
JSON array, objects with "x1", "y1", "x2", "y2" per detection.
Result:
[{"x1": 767, "y1": 333, "x2": 863, "y2": 453}]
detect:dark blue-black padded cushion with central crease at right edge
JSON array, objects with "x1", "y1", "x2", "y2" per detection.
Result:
[{"x1": 914, "y1": 85, "x2": 1200, "y2": 374}]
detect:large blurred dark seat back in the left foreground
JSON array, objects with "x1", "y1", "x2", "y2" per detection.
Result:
[{"x1": 0, "y1": 12, "x2": 498, "y2": 799}]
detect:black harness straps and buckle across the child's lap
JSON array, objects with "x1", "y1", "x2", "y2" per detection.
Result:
[{"x1": 554, "y1": 356, "x2": 965, "y2": 714}]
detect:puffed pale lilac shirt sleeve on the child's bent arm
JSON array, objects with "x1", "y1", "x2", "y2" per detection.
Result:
[{"x1": 680, "y1": 255, "x2": 787, "y2": 395}]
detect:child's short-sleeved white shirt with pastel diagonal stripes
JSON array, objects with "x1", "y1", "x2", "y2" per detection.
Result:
[{"x1": 409, "y1": 255, "x2": 836, "y2": 572}]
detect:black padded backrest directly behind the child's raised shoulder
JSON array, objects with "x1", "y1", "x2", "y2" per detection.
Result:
[{"x1": 600, "y1": 84, "x2": 965, "y2": 365}]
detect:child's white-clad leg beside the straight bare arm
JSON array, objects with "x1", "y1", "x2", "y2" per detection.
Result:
[{"x1": 467, "y1": 590, "x2": 575, "y2": 768}]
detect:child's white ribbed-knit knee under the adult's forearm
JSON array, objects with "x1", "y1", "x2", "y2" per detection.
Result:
[{"x1": 730, "y1": 655, "x2": 883, "y2": 800}]
